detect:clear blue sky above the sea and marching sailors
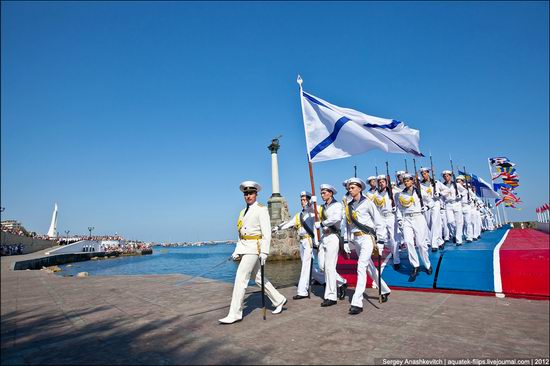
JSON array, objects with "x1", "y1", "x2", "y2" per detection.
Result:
[{"x1": 1, "y1": 2, "x2": 549, "y2": 241}]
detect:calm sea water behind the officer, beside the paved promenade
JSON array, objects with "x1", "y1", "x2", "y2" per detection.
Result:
[{"x1": 57, "y1": 243, "x2": 301, "y2": 286}]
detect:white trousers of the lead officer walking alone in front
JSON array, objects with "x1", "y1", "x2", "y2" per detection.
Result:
[{"x1": 229, "y1": 254, "x2": 285, "y2": 319}]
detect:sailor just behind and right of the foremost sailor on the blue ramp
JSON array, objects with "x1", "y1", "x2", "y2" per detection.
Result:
[{"x1": 420, "y1": 167, "x2": 447, "y2": 252}]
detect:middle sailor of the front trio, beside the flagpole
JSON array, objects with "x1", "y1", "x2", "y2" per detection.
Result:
[{"x1": 315, "y1": 184, "x2": 342, "y2": 307}]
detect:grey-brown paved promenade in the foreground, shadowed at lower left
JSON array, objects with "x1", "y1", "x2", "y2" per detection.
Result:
[{"x1": 1, "y1": 247, "x2": 550, "y2": 365}]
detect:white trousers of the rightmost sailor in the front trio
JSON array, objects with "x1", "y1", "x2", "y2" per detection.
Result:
[{"x1": 351, "y1": 235, "x2": 390, "y2": 308}]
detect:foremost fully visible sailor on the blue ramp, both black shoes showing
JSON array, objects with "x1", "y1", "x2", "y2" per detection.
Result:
[{"x1": 395, "y1": 174, "x2": 432, "y2": 277}]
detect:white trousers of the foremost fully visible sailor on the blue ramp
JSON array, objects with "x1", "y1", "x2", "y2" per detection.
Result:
[{"x1": 403, "y1": 214, "x2": 431, "y2": 269}]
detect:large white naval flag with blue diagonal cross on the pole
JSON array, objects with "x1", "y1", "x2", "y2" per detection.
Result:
[{"x1": 301, "y1": 91, "x2": 424, "y2": 162}]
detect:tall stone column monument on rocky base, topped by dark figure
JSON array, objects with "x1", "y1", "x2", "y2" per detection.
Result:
[{"x1": 267, "y1": 136, "x2": 300, "y2": 260}]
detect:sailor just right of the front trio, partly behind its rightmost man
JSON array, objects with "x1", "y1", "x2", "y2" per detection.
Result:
[{"x1": 373, "y1": 174, "x2": 401, "y2": 271}]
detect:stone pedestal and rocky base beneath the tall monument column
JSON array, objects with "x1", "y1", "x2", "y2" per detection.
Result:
[{"x1": 267, "y1": 193, "x2": 300, "y2": 260}]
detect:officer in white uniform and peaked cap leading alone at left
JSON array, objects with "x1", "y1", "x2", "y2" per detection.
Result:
[{"x1": 219, "y1": 181, "x2": 287, "y2": 324}]
